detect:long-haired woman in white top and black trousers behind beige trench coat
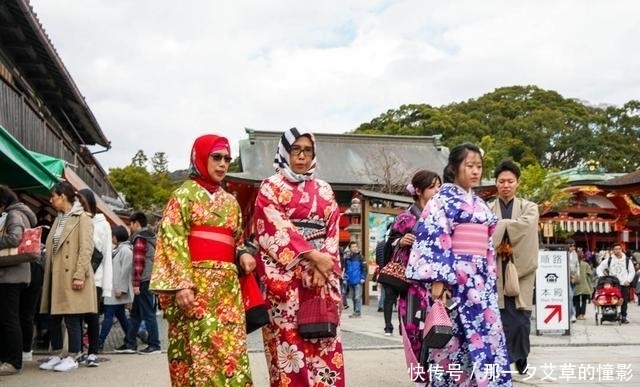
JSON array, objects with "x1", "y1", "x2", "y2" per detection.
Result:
[{"x1": 78, "y1": 188, "x2": 113, "y2": 367}]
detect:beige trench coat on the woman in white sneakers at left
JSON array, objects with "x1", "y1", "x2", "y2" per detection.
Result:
[{"x1": 40, "y1": 206, "x2": 98, "y2": 314}]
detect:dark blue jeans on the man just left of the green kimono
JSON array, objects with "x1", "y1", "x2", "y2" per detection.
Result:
[{"x1": 124, "y1": 281, "x2": 160, "y2": 349}]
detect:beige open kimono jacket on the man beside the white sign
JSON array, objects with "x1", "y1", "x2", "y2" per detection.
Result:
[{"x1": 489, "y1": 197, "x2": 539, "y2": 310}]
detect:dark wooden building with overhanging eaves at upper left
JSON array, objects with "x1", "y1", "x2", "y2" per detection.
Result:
[{"x1": 0, "y1": 0, "x2": 125, "y2": 224}]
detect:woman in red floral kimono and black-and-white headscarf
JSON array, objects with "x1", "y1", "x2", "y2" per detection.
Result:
[{"x1": 255, "y1": 128, "x2": 345, "y2": 387}]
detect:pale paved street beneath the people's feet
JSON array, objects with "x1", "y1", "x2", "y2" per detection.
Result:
[{"x1": 0, "y1": 298, "x2": 640, "y2": 387}]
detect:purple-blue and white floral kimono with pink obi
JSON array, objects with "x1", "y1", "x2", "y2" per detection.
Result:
[{"x1": 406, "y1": 184, "x2": 512, "y2": 387}]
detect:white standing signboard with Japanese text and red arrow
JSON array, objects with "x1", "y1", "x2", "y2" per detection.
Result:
[{"x1": 536, "y1": 251, "x2": 572, "y2": 335}]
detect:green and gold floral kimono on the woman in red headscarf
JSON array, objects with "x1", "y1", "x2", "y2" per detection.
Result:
[{"x1": 150, "y1": 180, "x2": 253, "y2": 387}]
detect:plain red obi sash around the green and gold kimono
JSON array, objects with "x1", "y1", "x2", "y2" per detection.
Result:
[{"x1": 188, "y1": 226, "x2": 236, "y2": 262}]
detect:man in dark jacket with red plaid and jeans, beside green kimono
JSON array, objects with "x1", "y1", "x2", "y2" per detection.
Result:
[{"x1": 116, "y1": 212, "x2": 160, "y2": 355}]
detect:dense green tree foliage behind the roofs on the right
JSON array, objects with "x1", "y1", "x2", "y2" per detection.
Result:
[{"x1": 354, "y1": 86, "x2": 640, "y2": 207}]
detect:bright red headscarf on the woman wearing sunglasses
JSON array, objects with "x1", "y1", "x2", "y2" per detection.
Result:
[{"x1": 189, "y1": 134, "x2": 231, "y2": 193}]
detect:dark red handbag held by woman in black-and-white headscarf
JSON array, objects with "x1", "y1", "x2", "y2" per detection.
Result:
[{"x1": 298, "y1": 289, "x2": 340, "y2": 339}]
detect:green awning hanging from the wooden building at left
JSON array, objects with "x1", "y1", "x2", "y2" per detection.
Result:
[{"x1": 0, "y1": 126, "x2": 65, "y2": 196}]
